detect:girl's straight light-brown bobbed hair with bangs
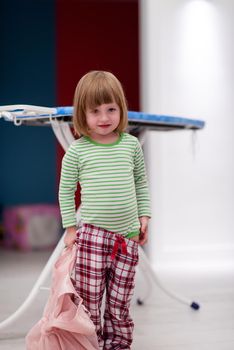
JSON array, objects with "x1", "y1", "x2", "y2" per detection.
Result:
[{"x1": 73, "y1": 71, "x2": 128, "y2": 136}]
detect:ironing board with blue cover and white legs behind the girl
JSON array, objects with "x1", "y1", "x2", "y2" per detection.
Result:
[{"x1": 0, "y1": 105, "x2": 205, "y2": 330}]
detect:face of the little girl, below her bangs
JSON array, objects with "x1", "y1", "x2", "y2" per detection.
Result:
[{"x1": 86, "y1": 102, "x2": 120, "y2": 139}]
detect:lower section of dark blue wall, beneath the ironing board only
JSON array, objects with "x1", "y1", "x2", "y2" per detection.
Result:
[{"x1": 0, "y1": 121, "x2": 56, "y2": 206}]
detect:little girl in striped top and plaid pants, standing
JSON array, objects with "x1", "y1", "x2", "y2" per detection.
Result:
[{"x1": 59, "y1": 71, "x2": 151, "y2": 350}]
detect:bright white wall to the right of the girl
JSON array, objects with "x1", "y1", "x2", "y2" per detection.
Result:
[{"x1": 140, "y1": 0, "x2": 234, "y2": 269}]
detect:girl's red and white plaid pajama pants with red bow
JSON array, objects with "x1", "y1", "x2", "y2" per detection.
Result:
[{"x1": 75, "y1": 224, "x2": 138, "y2": 350}]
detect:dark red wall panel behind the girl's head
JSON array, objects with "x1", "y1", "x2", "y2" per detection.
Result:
[{"x1": 56, "y1": 0, "x2": 139, "y2": 208}]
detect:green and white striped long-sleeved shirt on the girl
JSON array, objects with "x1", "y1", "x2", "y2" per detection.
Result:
[{"x1": 59, "y1": 133, "x2": 151, "y2": 237}]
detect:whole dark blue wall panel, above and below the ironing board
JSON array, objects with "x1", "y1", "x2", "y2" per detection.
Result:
[{"x1": 0, "y1": 0, "x2": 57, "y2": 206}]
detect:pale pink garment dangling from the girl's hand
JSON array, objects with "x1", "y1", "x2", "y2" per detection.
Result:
[{"x1": 26, "y1": 245, "x2": 99, "y2": 350}]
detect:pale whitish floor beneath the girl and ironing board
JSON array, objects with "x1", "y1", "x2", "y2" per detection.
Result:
[{"x1": 0, "y1": 250, "x2": 234, "y2": 350}]
